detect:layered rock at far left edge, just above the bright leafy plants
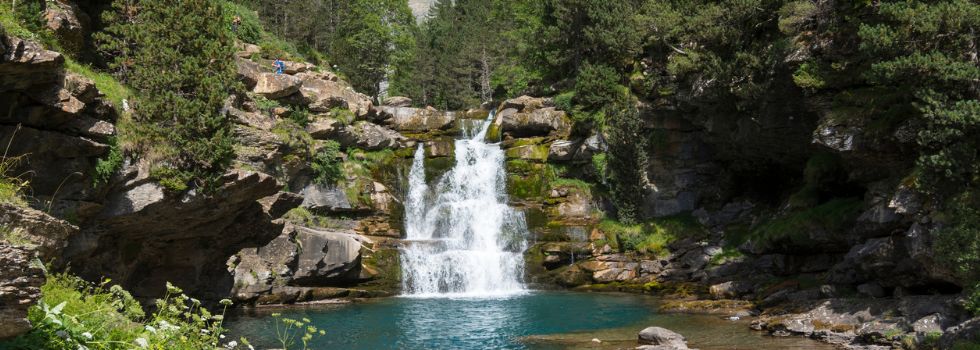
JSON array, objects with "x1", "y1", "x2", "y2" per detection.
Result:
[{"x1": 0, "y1": 240, "x2": 44, "y2": 340}]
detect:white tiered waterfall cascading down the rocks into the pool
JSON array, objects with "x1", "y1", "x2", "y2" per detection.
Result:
[{"x1": 401, "y1": 114, "x2": 527, "y2": 297}]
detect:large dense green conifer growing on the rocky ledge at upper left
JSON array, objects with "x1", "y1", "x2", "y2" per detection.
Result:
[{"x1": 96, "y1": 0, "x2": 239, "y2": 192}]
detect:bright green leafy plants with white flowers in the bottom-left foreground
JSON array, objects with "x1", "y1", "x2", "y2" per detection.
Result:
[{"x1": 0, "y1": 274, "x2": 239, "y2": 350}]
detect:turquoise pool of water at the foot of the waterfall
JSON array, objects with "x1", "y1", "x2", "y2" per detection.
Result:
[{"x1": 228, "y1": 291, "x2": 833, "y2": 350}]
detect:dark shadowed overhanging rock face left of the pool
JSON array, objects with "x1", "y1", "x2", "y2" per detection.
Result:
[{"x1": 65, "y1": 171, "x2": 286, "y2": 299}]
